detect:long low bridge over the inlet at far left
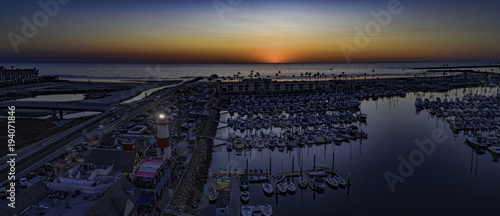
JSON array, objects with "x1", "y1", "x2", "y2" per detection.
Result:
[{"x1": 0, "y1": 101, "x2": 112, "y2": 119}]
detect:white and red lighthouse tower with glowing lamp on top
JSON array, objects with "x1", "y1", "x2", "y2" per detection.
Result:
[{"x1": 155, "y1": 106, "x2": 171, "y2": 160}]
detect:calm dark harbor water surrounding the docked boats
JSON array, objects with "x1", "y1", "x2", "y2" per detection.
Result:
[{"x1": 200, "y1": 88, "x2": 500, "y2": 215}]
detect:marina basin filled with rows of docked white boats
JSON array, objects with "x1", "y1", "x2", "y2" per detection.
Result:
[{"x1": 200, "y1": 78, "x2": 499, "y2": 215}]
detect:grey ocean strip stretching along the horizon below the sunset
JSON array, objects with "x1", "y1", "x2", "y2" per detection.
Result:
[{"x1": 0, "y1": 61, "x2": 498, "y2": 79}]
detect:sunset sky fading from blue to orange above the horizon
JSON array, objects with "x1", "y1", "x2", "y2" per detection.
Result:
[{"x1": 0, "y1": 0, "x2": 500, "y2": 63}]
